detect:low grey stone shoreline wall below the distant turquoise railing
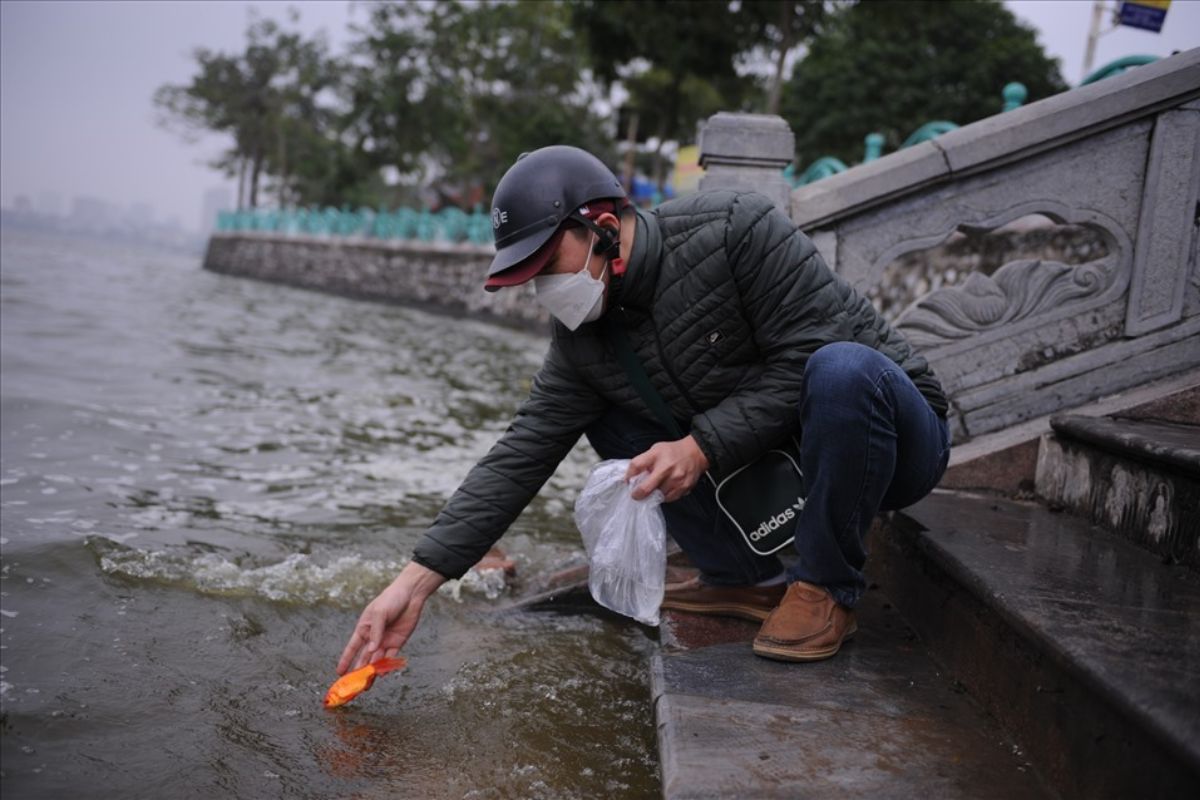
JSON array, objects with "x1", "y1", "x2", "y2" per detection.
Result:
[{"x1": 204, "y1": 231, "x2": 550, "y2": 331}]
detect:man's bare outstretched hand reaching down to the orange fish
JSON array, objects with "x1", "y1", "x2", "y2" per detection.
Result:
[{"x1": 337, "y1": 561, "x2": 446, "y2": 675}]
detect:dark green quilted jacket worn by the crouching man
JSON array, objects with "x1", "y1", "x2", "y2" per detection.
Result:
[{"x1": 414, "y1": 191, "x2": 947, "y2": 578}]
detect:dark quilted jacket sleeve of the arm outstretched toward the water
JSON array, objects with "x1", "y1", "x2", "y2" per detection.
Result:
[{"x1": 413, "y1": 344, "x2": 605, "y2": 578}]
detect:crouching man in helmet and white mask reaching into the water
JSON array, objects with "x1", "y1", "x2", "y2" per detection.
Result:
[{"x1": 338, "y1": 146, "x2": 949, "y2": 673}]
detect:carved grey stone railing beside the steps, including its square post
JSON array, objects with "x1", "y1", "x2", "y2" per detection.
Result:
[{"x1": 701, "y1": 49, "x2": 1200, "y2": 443}]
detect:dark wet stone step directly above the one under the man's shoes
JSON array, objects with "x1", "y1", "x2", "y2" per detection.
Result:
[{"x1": 872, "y1": 491, "x2": 1200, "y2": 798}]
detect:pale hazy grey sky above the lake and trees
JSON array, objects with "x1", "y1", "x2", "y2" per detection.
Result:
[{"x1": 0, "y1": 0, "x2": 1200, "y2": 229}]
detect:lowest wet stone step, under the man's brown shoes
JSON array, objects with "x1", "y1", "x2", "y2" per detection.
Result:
[{"x1": 652, "y1": 590, "x2": 1054, "y2": 800}]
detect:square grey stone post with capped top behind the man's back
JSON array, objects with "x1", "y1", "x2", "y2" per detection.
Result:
[{"x1": 700, "y1": 112, "x2": 796, "y2": 215}]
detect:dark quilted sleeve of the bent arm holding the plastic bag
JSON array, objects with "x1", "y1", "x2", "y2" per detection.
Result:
[{"x1": 692, "y1": 194, "x2": 924, "y2": 474}]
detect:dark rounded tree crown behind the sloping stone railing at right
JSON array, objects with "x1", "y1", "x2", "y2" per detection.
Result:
[{"x1": 781, "y1": 0, "x2": 1066, "y2": 166}]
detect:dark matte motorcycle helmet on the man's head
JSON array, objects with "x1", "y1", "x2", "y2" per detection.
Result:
[{"x1": 487, "y1": 145, "x2": 625, "y2": 289}]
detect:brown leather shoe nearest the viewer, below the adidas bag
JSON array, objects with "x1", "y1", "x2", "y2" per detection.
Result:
[{"x1": 754, "y1": 581, "x2": 858, "y2": 661}]
